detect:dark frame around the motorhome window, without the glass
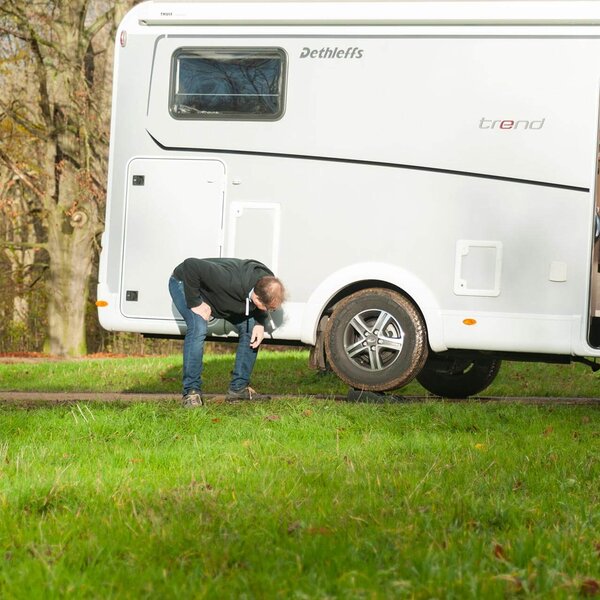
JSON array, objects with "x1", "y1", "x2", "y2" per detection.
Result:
[{"x1": 168, "y1": 46, "x2": 288, "y2": 121}]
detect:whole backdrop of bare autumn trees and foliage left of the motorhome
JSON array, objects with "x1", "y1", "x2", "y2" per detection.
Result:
[{"x1": 0, "y1": 0, "x2": 136, "y2": 355}]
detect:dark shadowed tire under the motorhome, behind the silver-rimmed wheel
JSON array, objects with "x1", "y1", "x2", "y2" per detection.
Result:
[{"x1": 417, "y1": 354, "x2": 502, "y2": 398}]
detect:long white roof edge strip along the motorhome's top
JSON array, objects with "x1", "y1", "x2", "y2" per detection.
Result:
[{"x1": 132, "y1": 0, "x2": 600, "y2": 25}]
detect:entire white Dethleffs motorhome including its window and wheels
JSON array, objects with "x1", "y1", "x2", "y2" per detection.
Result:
[{"x1": 98, "y1": 0, "x2": 600, "y2": 395}]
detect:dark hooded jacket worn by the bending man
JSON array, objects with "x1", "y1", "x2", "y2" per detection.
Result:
[{"x1": 173, "y1": 258, "x2": 273, "y2": 325}]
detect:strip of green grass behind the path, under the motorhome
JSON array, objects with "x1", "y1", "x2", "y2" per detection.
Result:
[{"x1": 0, "y1": 350, "x2": 600, "y2": 398}]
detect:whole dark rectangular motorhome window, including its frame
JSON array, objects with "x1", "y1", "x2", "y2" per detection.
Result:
[{"x1": 170, "y1": 48, "x2": 285, "y2": 120}]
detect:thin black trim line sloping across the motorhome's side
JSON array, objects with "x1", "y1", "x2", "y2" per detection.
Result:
[{"x1": 146, "y1": 130, "x2": 590, "y2": 194}]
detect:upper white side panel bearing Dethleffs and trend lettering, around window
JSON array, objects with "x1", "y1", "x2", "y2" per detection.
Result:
[{"x1": 146, "y1": 34, "x2": 600, "y2": 188}]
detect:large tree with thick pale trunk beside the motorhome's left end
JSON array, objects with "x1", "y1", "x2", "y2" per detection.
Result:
[{"x1": 0, "y1": 0, "x2": 133, "y2": 356}]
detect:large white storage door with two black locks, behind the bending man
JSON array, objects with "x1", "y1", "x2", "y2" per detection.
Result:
[{"x1": 121, "y1": 158, "x2": 225, "y2": 319}]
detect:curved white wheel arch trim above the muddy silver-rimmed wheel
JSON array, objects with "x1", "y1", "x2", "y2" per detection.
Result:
[{"x1": 302, "y1": 263, "x2": 447, "y2": 352}]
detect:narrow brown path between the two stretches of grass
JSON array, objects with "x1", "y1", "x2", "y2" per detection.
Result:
[{"x1": 0, "y1": 391, "x2": 600, "y2": 407}]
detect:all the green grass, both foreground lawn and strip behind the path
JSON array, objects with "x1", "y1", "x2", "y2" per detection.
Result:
[{"x1": 0, "y1": 352, "x2": 600, "y2": 599}]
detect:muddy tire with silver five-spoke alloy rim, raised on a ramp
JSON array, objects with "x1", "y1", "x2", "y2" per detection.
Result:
[{"x1": 325, "y1": 288, "x2": 427, "y2": 392}]
